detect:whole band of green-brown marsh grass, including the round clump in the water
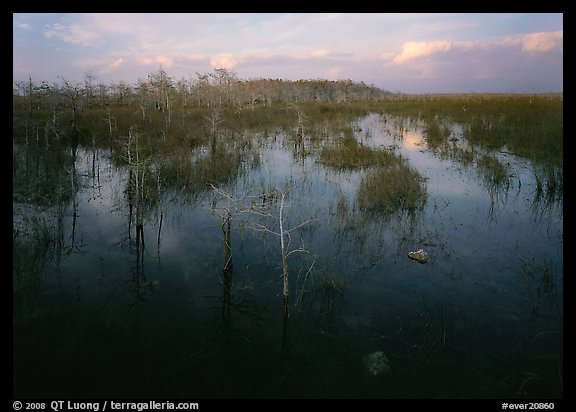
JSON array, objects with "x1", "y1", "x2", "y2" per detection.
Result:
[{"x1": 13, "y1": 95, "x2": 563, "y2": 210}]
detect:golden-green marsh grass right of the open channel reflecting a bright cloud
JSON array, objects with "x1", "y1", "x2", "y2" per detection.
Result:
[{"x1": 379, "y1": 94, "x2": 564, "y2": 199}]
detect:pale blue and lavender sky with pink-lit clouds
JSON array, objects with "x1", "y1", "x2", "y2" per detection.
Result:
[{"x1": 13, "y1": 13, "x2": 564, "y2": 93}]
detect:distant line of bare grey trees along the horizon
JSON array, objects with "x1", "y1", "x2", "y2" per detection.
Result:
[{"x1": 13, "y1": 68, "x2": 392, "y2": 117}]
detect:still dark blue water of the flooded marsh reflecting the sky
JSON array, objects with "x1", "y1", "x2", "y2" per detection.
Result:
[{"x1": 13, "y1": 114, "x2": 563, "y2": 399}]
